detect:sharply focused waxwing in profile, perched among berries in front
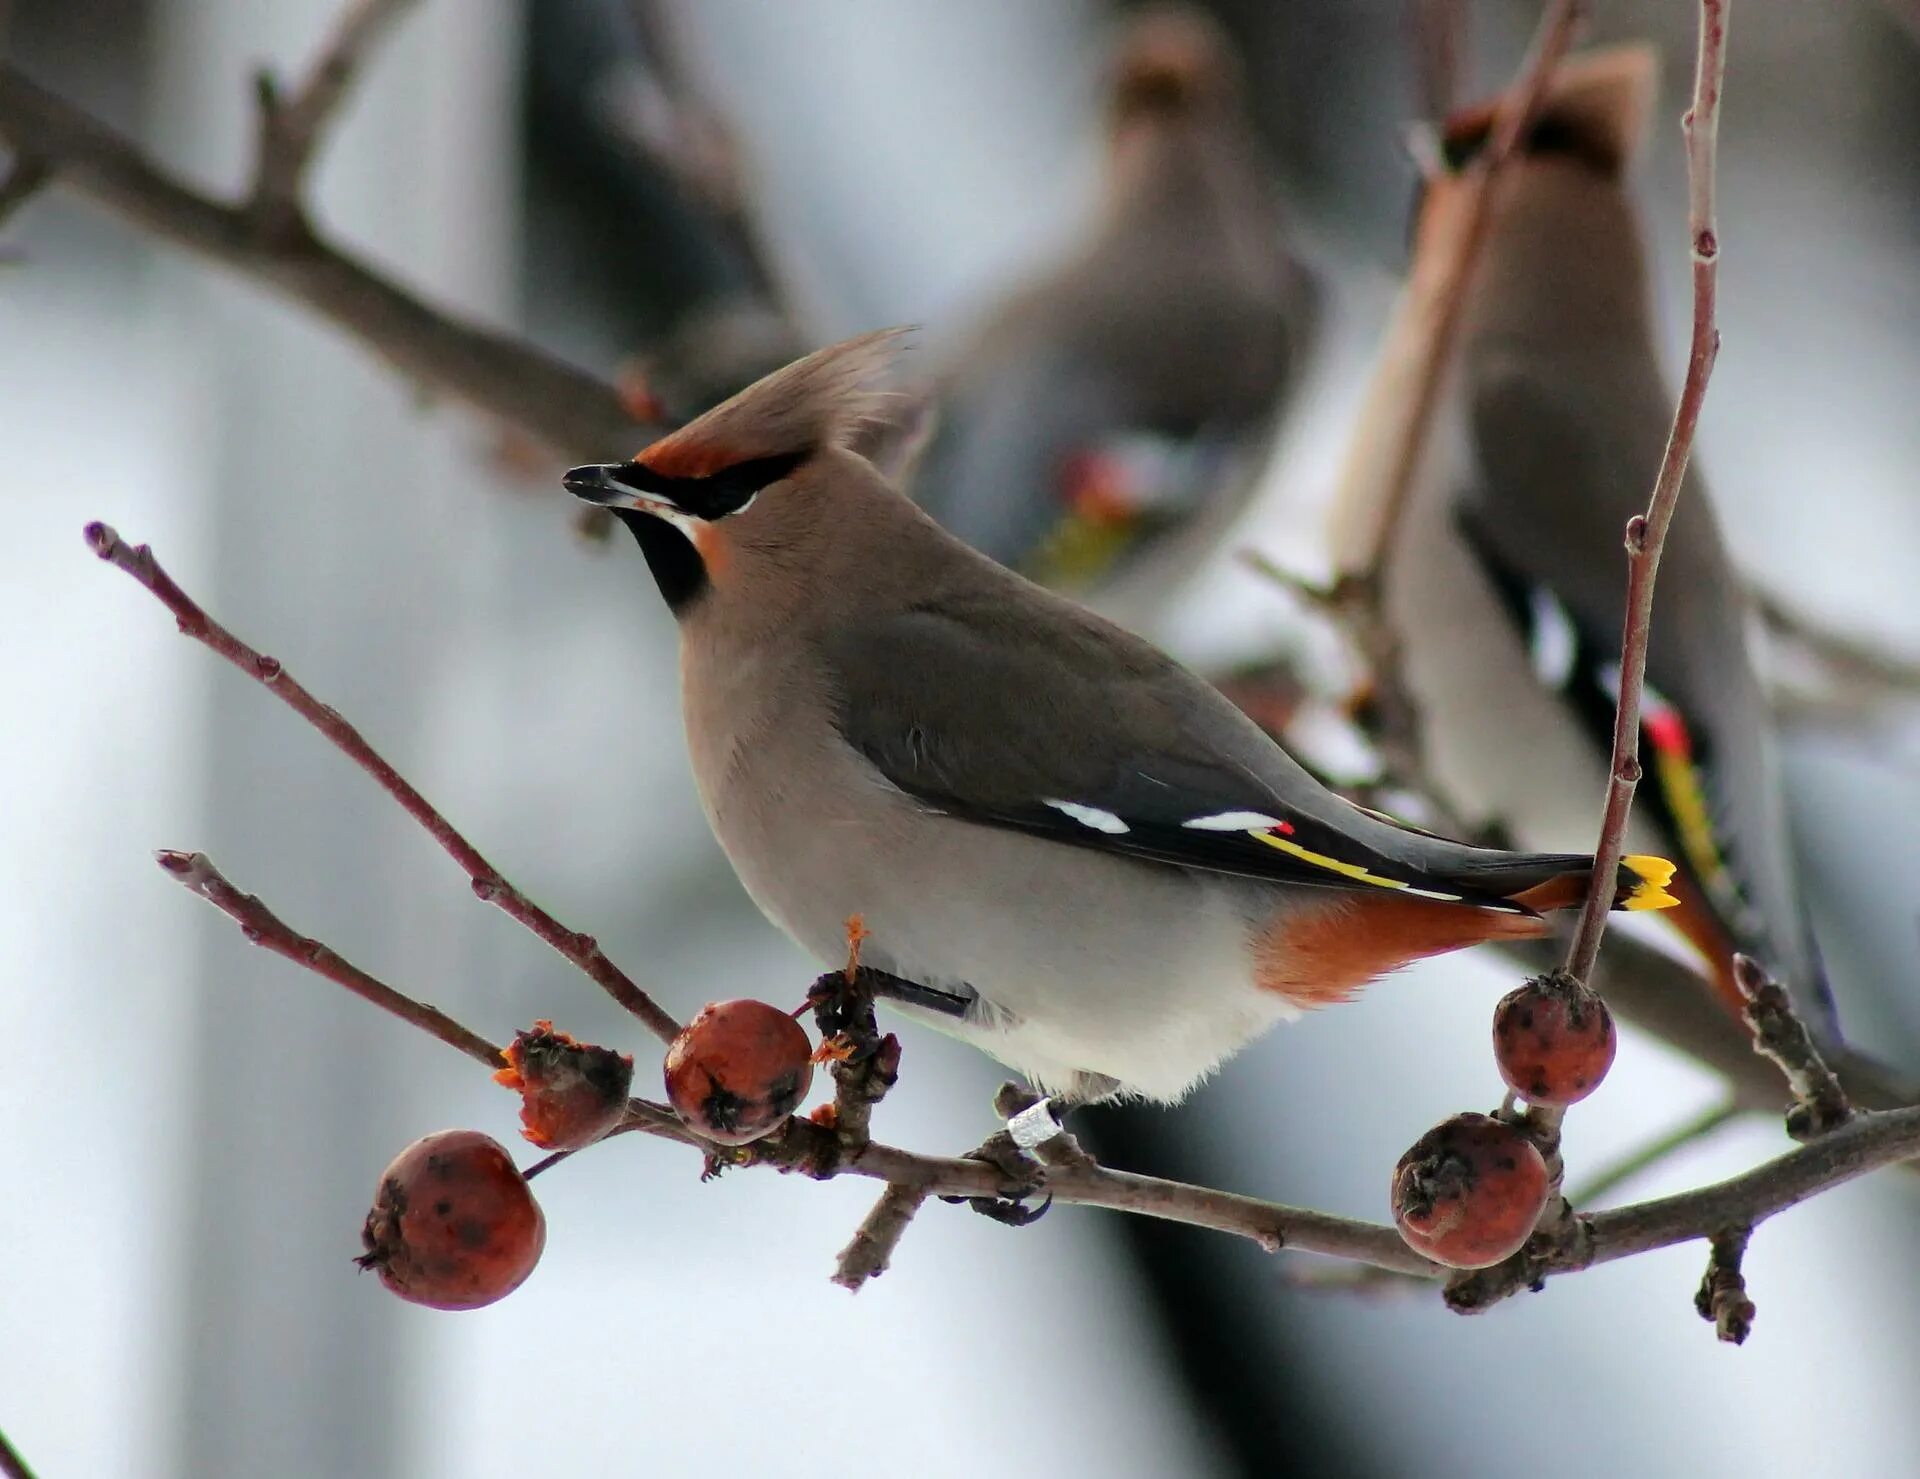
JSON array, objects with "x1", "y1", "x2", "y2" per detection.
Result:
[{"x1": 566, "y1": 332, "x2": 1672, "y2": 1101}]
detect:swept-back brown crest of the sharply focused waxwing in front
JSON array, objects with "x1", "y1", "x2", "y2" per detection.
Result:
[{"x1": 634, "y1": 328, "x2": 910, "y2": 478}]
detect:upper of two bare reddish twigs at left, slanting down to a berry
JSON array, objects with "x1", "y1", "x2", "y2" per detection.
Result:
[{"x1": 86, "y1": 522, "x2": 680, "y2": 1043}]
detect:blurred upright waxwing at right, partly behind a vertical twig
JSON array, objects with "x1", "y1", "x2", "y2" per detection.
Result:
[{"x1": 1332, "y1": 46, "x2": 1889, "y2": 1089}]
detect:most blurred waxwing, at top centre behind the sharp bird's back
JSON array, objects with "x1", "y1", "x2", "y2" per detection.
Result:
[{"x1": 912, "y1": 6, "x2": 1313, "y2": 590}]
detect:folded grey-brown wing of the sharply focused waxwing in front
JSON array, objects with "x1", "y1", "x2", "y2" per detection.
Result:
[{"x1": 826, "y1": 594, "x2": 1590, "y2": 912}]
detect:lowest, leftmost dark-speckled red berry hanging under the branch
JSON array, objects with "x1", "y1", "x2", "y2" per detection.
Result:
[{"x1": 355, "y1": 1129, "x2": 547, "y2": 1310}]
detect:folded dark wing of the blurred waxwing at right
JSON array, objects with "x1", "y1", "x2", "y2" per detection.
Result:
[{"x1": 1457, "y1": 348, "x2": 1832, "y2": 1024}]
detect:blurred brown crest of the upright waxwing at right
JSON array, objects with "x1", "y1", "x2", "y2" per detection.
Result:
[{"x1": 1442, "y1": 42, "x2": 1659, "y2": 175}]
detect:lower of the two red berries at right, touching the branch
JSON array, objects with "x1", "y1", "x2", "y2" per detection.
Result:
[{"x1": 1394, "y1": 1114, "x2": 1548, "y2": 1268}]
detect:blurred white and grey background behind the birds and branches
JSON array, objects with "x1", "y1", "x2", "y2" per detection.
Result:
[{"x1": 0, "y1": 0, "x2": 1920, "y2": 1479}]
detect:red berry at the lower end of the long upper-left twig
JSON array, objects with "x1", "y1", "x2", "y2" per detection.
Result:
[{"x1": 666, "y1": 1001, "x2": 814, "y2": 1145}]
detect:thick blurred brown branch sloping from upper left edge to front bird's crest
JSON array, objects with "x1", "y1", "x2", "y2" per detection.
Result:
[{"x1": 0, "y1": 63, "x2": 649, "y2": 451}]
